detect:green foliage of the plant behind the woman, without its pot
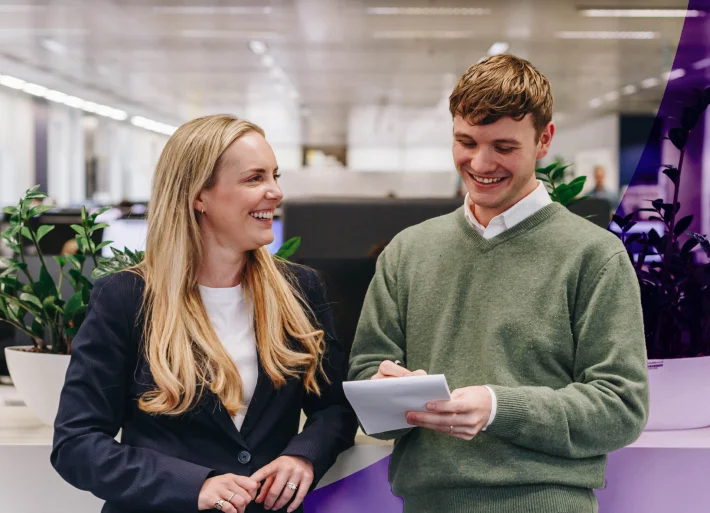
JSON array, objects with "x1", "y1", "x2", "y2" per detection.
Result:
[{"x1": 0, "y1": 186, "x2": 301, "y2": 355}]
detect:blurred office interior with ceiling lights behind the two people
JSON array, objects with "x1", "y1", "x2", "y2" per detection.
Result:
[{"x1": 0, "y1": 0, "x2": 710, "y2": 366}]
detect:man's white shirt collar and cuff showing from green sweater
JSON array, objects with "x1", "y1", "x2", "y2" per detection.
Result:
[{"x1": 463, "y1": 180, "x2": 552, "y2": 431}]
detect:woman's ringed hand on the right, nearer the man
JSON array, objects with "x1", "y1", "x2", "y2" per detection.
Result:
[{"x1": 251, "y1": 456, "x2": 313, "y2": 513}]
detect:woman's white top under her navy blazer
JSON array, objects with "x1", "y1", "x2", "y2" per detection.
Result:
[{"x1": 199, "y1": 285, "x2": 259, "y2": 429}]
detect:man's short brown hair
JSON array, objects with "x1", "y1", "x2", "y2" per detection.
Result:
[{"x1": 449, "y1": 54, "x2": 552, "y2": 139}]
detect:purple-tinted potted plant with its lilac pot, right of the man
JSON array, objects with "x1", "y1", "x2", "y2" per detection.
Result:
[{"x1": 613, "y1": 88, "x2": 710, "y2": 430}]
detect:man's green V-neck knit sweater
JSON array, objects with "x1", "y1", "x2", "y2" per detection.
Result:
[{"x1": 350, "y1": 203, "x2": 648, "y2": 513}]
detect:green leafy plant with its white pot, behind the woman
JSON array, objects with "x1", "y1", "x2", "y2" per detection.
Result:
[{"x1": 0, "y1": 186, "x2": 300, "y2": 425}]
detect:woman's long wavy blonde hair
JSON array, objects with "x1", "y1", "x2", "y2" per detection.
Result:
[{"x1": 135, "y1": 115, "x2": 325, "y2": 416}]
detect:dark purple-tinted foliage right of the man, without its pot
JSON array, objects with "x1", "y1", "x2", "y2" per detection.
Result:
[{"x1": 614, "y1": 87, "x2": 710, "y2": 359}]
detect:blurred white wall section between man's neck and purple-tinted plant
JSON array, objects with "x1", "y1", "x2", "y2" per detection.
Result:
[{"x1": 543, "y1": 114, "x2": 619, "y2": 192}]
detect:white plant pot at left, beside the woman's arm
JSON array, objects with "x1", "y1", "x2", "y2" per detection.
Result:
[{"x1": 5, "y1": 346, "x2": 71, "y2": 426}]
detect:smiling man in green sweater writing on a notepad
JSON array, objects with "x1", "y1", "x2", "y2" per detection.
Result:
[{"x1": 349, "y1": 55, "x2": 648, "y2": 513}]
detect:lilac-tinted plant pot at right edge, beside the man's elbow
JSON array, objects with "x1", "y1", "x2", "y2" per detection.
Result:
[{"x1": 646, "y1": 356, "x2": 710, "y2": 431}]
